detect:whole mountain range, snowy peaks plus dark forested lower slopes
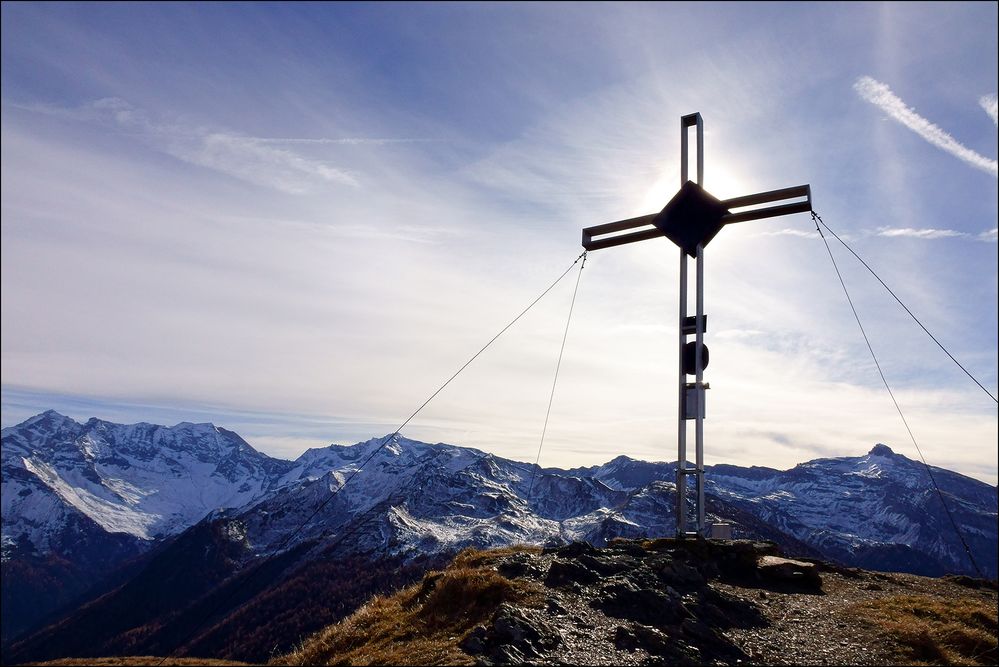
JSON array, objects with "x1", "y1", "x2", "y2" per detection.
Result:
[{"x1": 0, "y1": 411, "x2": 997, "y2": 662}]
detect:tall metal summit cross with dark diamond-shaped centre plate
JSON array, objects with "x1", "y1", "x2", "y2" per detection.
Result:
[{"x1": 583, "y1": 113, "x2": 812, "y2": 537}]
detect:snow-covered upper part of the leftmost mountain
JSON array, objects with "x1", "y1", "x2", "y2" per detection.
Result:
[{"x1": 2, "y1": 411, "x2": 291, "y2": 553}]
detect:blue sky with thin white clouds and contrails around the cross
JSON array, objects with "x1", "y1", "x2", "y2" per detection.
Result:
[{"x1": 0, "y1": 2, "x2": 999, "y2": 484}]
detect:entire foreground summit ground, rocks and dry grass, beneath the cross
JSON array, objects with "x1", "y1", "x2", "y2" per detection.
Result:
[{"x1": 279, "y1": 539, "x2": 997, "y2": 665}]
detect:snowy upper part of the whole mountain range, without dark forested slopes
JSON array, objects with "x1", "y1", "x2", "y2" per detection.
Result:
[{"x1": 2, "y1": 411, "x2": 997, "y2": 634}]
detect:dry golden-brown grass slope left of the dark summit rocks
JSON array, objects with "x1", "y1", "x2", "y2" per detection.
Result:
[{"x1": 274, "y1": 547, "x2": 543, "y2": 665}]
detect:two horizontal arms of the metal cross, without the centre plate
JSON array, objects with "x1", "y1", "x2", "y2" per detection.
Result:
[{"x1": 583, "y1": 185, "x2": 812, "y2": 250}]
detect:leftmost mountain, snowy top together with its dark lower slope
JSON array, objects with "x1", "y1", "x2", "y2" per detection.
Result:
[{"x1": 0, "y1": 411, "x2": 293, "y2": 637}]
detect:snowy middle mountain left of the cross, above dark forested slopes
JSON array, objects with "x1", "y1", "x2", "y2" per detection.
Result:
[{"x1": 230, "y1": 437, "x2": 636, "y2": 556}]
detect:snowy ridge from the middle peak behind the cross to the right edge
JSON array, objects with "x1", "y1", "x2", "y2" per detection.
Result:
[{"x1": 211, "y1": 437, "x2": 997, "y2": 577}]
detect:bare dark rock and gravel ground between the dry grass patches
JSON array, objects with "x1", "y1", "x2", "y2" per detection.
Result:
[{"x1": 402, "y1": 539, "x2": 997, "y2": 665}]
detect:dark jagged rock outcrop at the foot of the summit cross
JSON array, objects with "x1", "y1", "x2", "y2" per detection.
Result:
[{"x1": 460, "y1": 539, "x2": 796, "y2": 665}]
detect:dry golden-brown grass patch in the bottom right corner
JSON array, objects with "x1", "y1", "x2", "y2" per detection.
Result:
[{"x1": 853, "y1": 595, "x2": 999, "y2": 665}]
